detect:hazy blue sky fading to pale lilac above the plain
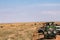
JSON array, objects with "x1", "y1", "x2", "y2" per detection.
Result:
[{"x1": 0, "y1": 0, "x2": 60, "y2": 23}]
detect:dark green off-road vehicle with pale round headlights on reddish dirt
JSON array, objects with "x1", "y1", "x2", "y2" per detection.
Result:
[{"x1": 38, "y1": 22, "x2": 56, "y2": 39}]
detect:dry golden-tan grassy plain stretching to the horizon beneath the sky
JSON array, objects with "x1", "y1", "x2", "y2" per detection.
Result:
[{"x1": 0, "y1": 22, "x2": 60, "y2": 40}]
